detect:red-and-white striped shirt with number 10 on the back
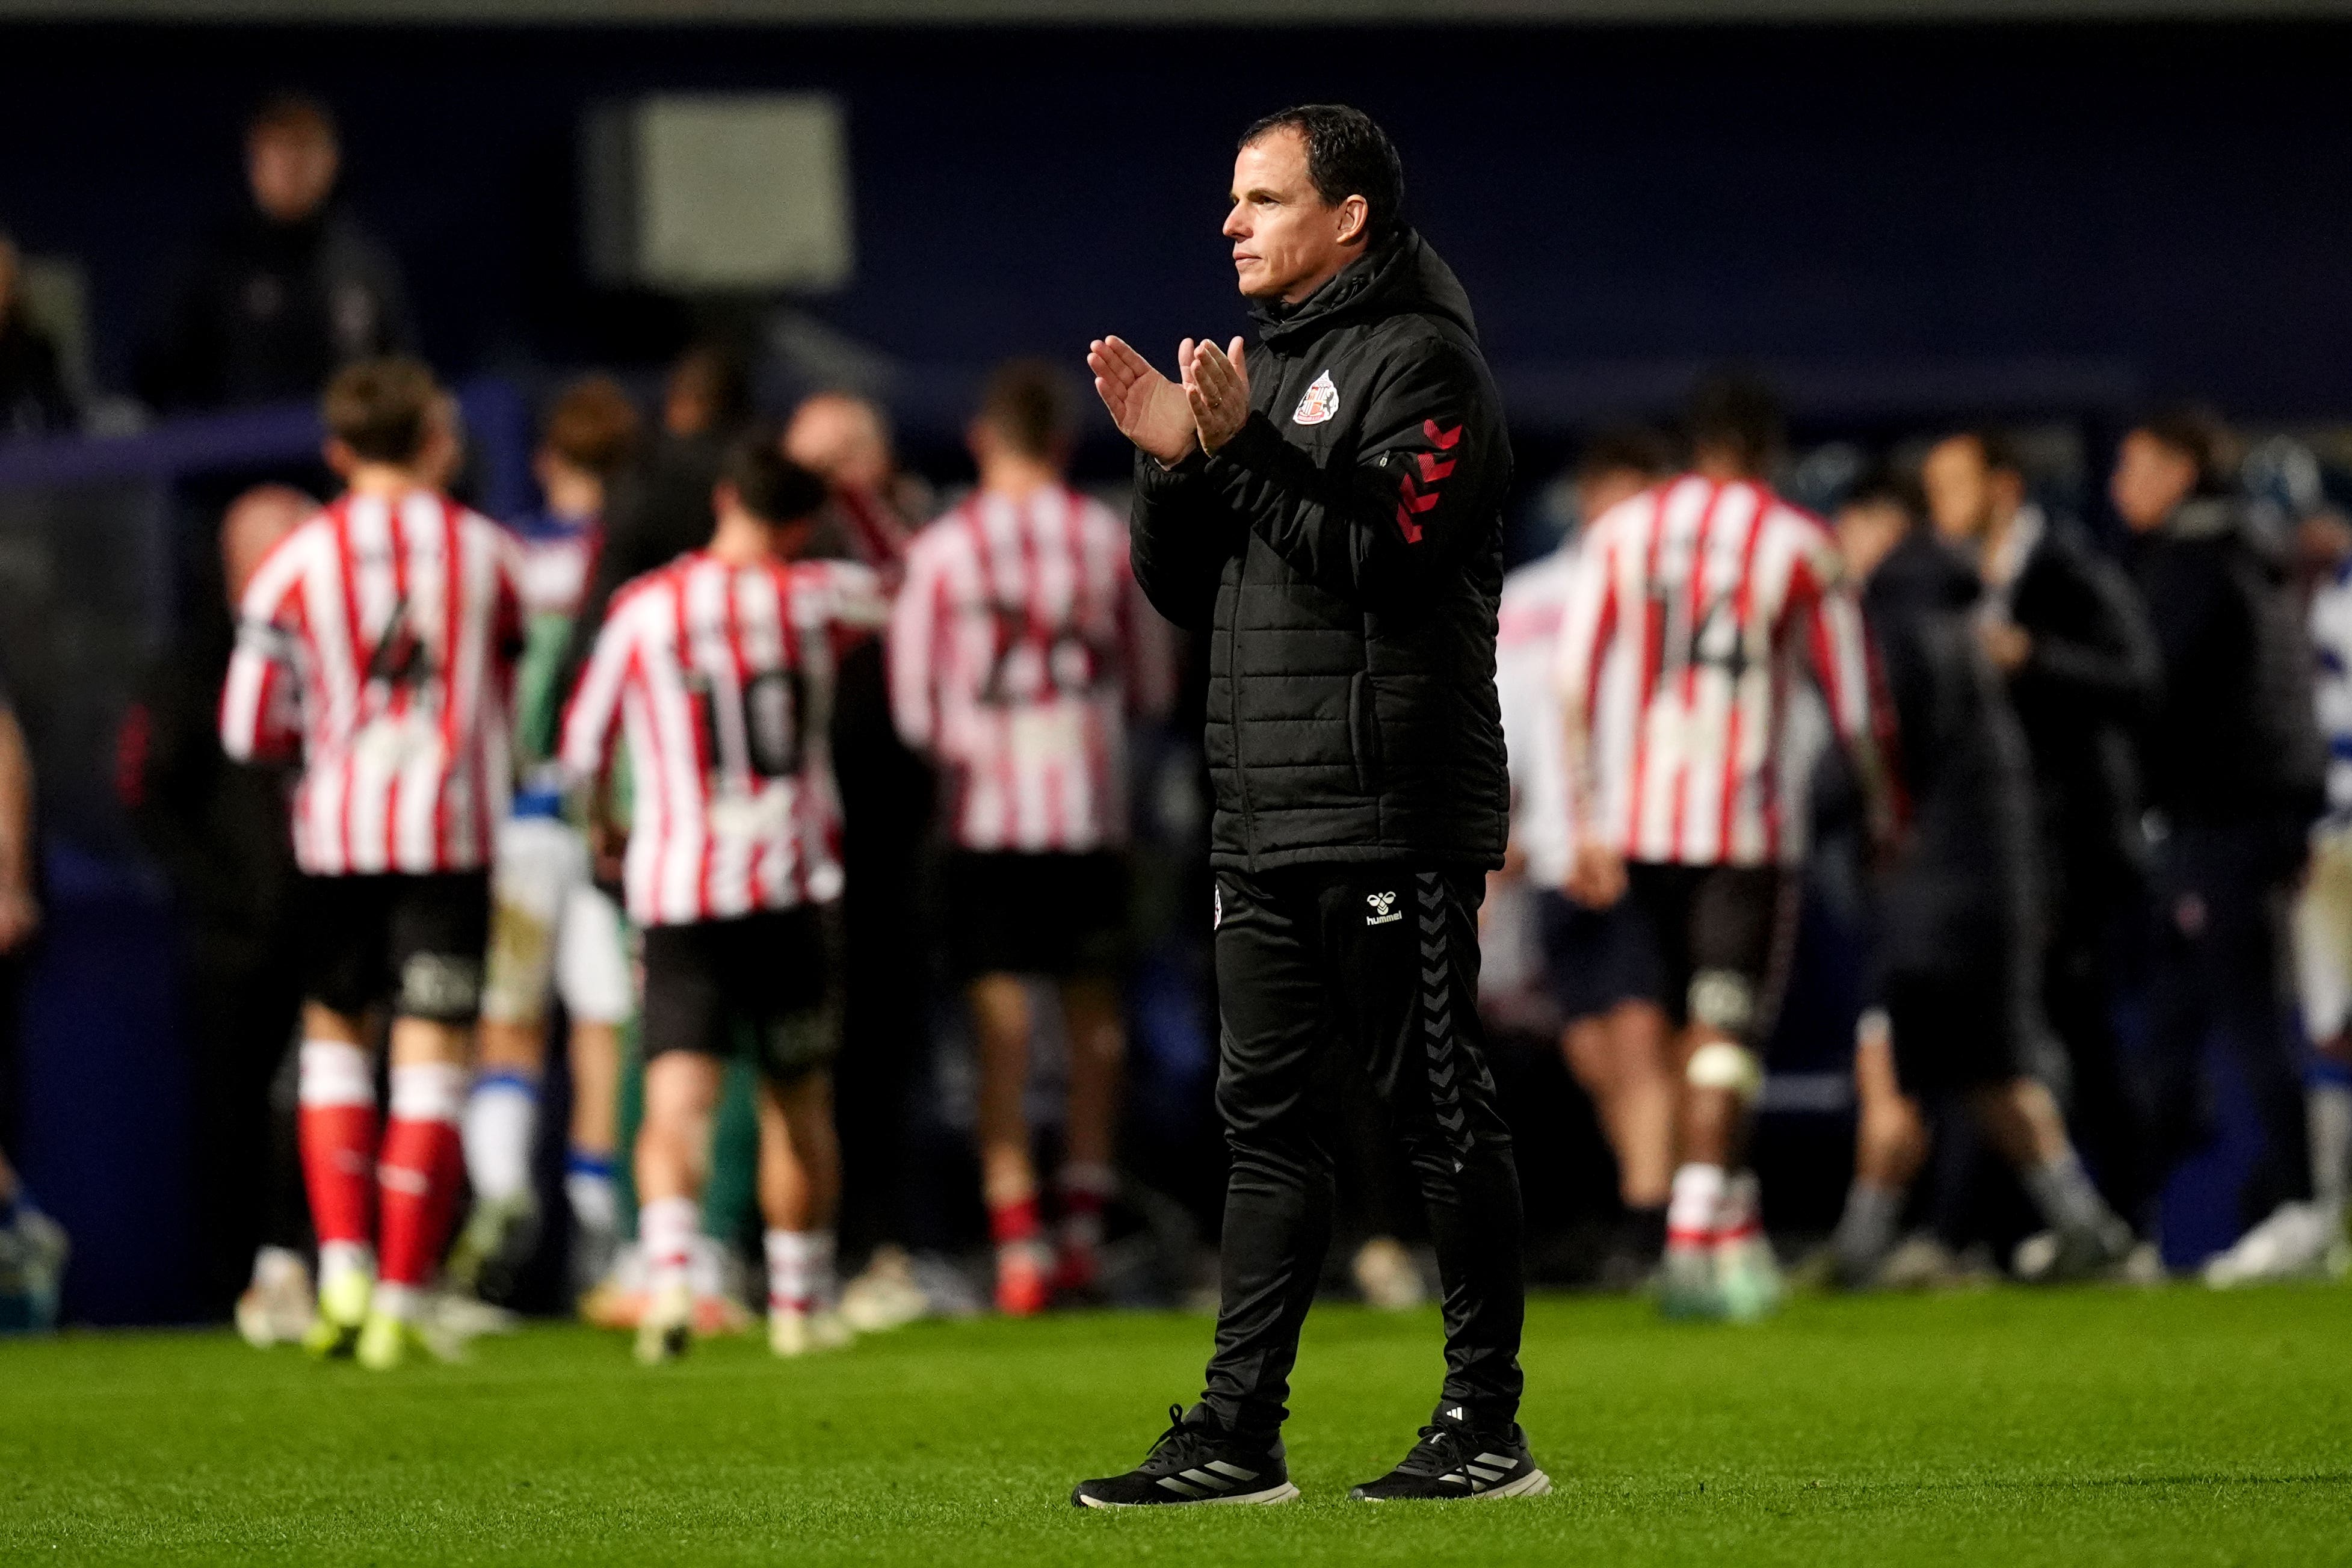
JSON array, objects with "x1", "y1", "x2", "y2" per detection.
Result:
[{"x1": 562, "y1": 550, "x2": 889, "y2": 926}]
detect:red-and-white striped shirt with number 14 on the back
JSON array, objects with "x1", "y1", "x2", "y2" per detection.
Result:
[{"x1": 1557, "y1": 475, "x2": 1886, "y2": 865}]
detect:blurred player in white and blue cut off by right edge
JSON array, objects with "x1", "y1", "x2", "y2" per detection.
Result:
[{"x1": 2204, "y1": 508, "x2": 2352, "y2": 1286}]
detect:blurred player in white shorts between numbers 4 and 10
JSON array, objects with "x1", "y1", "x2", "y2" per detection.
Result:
[{"x1": 449, "y1": 376, "x2": 637, "y2": 1300}]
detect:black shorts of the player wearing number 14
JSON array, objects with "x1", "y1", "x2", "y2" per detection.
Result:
[{"x1": 1625, "y1": 860, "x2": 1799, "y2": 1046}]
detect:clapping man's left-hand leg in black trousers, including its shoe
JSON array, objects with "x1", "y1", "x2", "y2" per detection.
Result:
[{"x1": 1070, "y1": 872, "x2": 1331, "y2": 1507}]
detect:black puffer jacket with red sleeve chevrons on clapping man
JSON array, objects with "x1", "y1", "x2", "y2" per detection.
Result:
[{"x1": 1134, "y1": 230, "x2": 1510, "y2": 870}]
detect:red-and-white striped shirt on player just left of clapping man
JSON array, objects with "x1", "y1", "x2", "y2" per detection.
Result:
[{"x1": 889, "y1": 487, "x2": 1174, "y2": 853}]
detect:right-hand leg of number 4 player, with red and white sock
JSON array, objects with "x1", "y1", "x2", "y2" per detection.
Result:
[{"x1": 360, "y1": 872, "x2": 489, "y2": 1368}]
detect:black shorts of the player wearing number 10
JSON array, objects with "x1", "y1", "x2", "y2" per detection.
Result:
[{"x1": 640, "y1": 905, "x2": 842, "y2": 1084}]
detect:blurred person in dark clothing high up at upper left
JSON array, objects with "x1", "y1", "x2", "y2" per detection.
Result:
[{"x1": 137, "y1": 94, "x2": 416, "y2": 412}]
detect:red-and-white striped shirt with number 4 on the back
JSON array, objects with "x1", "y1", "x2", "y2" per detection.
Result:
[{"x1": 221, "y1": 489, "x2": 522, "y2": 877}]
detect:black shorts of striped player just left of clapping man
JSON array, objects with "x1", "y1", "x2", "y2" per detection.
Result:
[{"x1": 941, "y1": 851, "x2": 1126, "y2": 980}]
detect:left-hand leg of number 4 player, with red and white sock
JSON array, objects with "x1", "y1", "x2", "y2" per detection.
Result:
[{"x1": 297, "y1": 877, "x2": 388, "y2": 1356}]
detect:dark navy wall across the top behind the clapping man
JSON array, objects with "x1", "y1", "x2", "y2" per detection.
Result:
[{"x1": 0, "y1": 23, "x2": 2352, "y2": 418}]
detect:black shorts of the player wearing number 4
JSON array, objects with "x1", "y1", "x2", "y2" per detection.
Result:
[{"x1": 298, "y1": 872, "x2": 489, "y2": 1023}]
